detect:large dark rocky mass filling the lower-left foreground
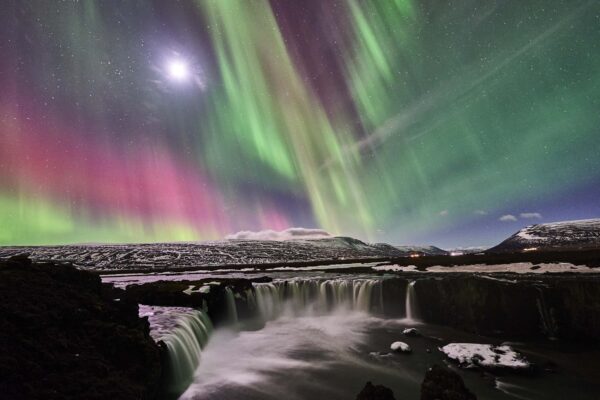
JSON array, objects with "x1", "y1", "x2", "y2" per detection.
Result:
[{"x1": 0, "y1": 257, "x2": 161, "y2": 400}]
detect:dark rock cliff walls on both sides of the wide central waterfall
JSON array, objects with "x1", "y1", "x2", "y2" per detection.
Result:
[{"x1": 115, "y1": 271, "x2": 600, "y2": 341}]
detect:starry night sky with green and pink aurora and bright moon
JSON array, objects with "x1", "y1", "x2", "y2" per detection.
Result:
[{"x1": 0, "y1": 0, "x2": 600, "y2": 244}]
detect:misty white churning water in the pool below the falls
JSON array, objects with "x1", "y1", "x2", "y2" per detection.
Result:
[{"x1": 182, "y1": 311, "x2": 412, "y2": 400}]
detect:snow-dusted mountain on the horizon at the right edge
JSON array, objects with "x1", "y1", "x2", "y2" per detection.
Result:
[{"x1": 488, "y1": 218, "x2": 600, "y2": 253}]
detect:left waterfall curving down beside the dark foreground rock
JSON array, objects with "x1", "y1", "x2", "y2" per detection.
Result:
[{"x1": 140, "y1": 305, "x2": 212, "y2": 396}]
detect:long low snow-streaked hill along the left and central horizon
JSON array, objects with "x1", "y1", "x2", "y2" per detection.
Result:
[{"x1": 0, "y1": 236, "x2": 447, "y2": 271}]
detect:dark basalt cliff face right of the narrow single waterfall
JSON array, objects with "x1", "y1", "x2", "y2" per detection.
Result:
[{"x1": 408, "y1": 274, "x2": 600, "y2": 341}]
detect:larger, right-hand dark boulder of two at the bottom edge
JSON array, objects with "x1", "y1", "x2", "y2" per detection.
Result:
[{"x1": 421, "y1": 365, "x2": 477, "y2": 400}]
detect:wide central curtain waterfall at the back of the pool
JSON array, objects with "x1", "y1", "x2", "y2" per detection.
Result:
[{"x1": 253, "y1": 279, "x2": 381, "y2": 320}]
